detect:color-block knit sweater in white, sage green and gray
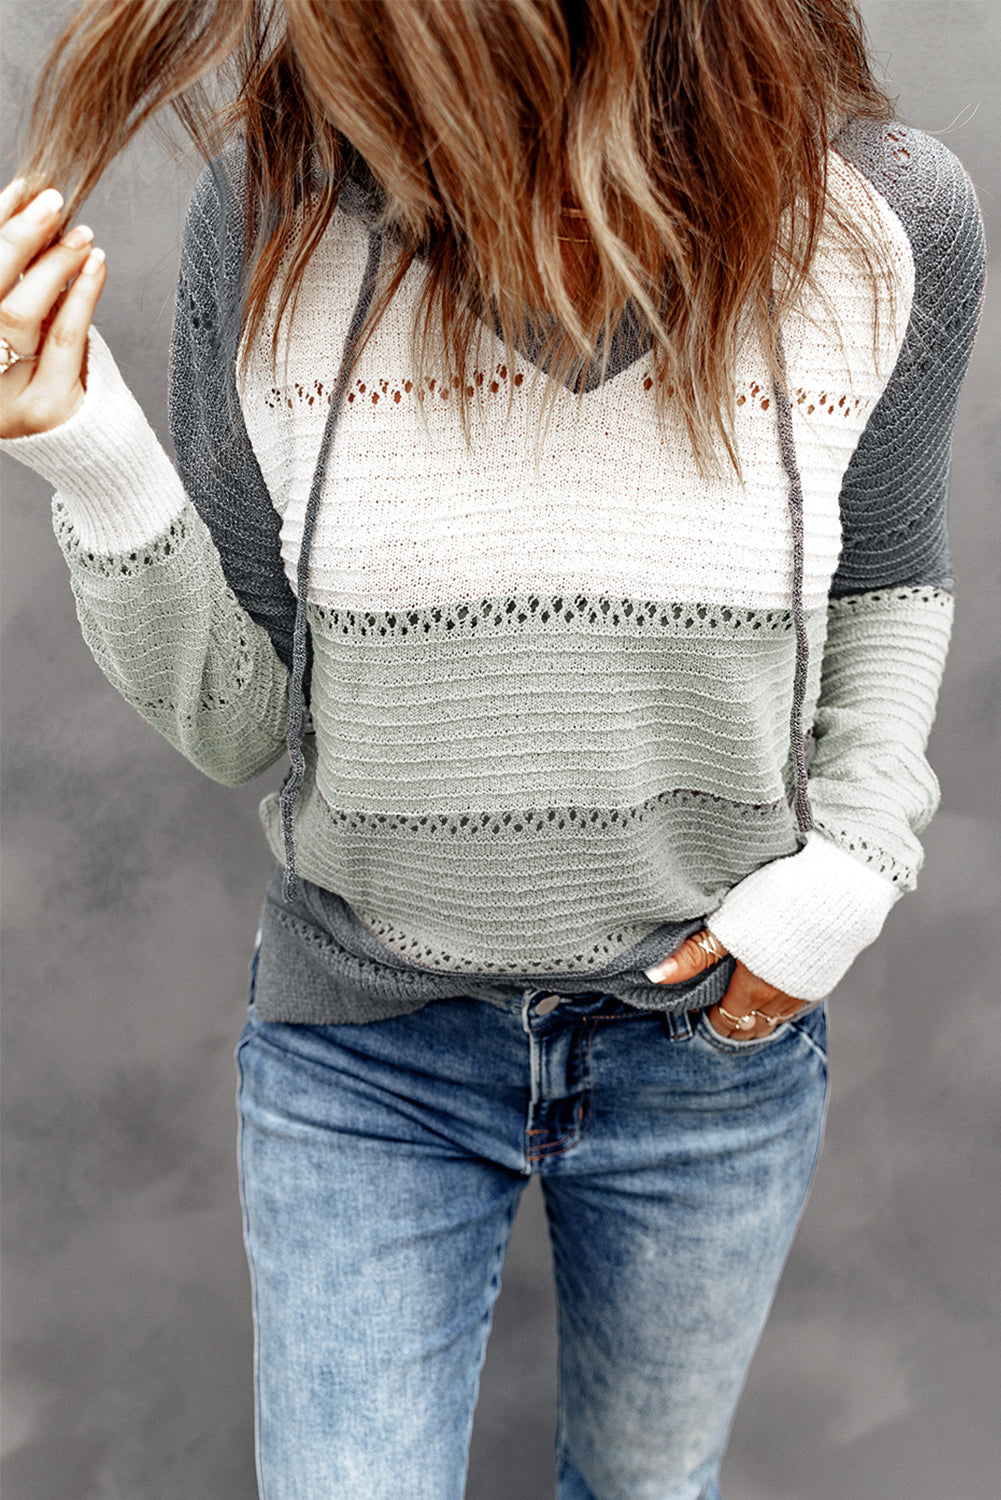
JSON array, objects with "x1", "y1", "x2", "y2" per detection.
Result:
[{"x1": 0, "y1": 122, "x2": 984, "y2": 1023}]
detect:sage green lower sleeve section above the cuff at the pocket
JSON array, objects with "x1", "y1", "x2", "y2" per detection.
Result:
[{"x1": 810, "y1": 588, "x2": 953, "y2": 890}]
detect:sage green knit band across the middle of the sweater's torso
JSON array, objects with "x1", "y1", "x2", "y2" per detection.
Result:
[{"x1": 314, "y1": 611, "x2": 824, "y2": 813}]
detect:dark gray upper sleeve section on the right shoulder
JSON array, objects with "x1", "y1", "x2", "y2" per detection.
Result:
[{"x1": 831, "y1": 120, "x2": 986, "y2": 599}]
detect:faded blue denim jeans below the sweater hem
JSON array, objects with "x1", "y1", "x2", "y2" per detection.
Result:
[{"x1": 237, "y1": 966, "x2": 827, "y2": 1500}]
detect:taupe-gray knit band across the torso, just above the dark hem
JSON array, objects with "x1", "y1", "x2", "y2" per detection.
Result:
[{"x1": 261, "y1": 755, "x2": 795, "y2": 974}]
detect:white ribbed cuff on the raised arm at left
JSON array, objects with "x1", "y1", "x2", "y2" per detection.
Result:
[{"x1": 0, "y1": 327, "x2": 186, "y2": 557}]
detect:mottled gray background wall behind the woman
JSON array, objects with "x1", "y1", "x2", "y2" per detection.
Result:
[{"x1": 0, "y1": 0, "x2": 1001, "y2": 1500}]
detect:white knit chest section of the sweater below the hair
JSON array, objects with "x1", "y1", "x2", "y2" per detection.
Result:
[{"x1": 242, "y1": 155, "x2": 912, "y2": 609}]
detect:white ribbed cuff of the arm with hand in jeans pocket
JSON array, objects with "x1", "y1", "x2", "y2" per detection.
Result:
[{"x1": 707, "y1": 833, "x2": 903, "y2": 1001}]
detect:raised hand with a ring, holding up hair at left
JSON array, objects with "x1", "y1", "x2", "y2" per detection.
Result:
[{"x1": 0, "y1": 179, "x2": 105, "y2": 438}]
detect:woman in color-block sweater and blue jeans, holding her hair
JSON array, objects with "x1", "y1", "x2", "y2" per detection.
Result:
[{"x1": 0, "y1": 0, "x2": 983, "y2": 1500}]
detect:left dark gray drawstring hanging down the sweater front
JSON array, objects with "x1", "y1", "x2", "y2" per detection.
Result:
[{"x1": 281, "y1": 233, "x2": 383, "y2": 900}]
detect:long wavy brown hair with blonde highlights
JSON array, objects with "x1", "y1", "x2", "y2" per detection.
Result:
[{"x1": 13, "y1": 0, "x2": 891, "y2": 467}]
